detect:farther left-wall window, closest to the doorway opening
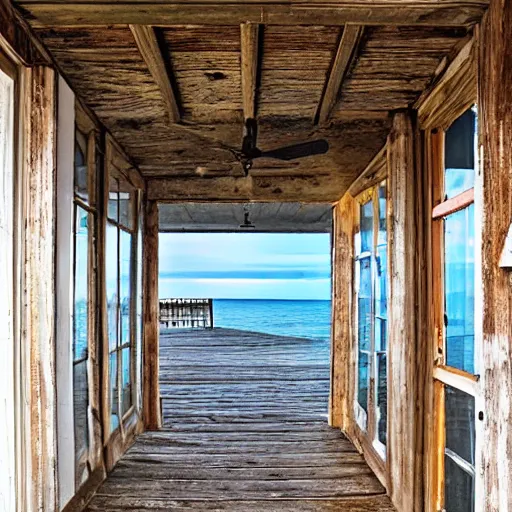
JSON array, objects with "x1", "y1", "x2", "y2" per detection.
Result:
[{"x1": 106, "y1": 176, "x2": 137, "y2": 431}]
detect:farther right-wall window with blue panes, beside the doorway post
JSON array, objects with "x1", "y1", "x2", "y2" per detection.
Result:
[{"x1": 355, "y1": 181, "x2": 388, "y2": 458}]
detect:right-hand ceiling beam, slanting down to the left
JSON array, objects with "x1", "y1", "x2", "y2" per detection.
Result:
[{"x1": 316, "y1": 25, "x2": 364, "y2": 124}]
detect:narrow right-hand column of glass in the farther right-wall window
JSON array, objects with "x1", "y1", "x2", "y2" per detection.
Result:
[{"x1": 375, "y1": 185, "x2": 388, "y2": 444}]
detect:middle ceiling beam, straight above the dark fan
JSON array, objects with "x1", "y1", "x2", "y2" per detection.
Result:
[{"x1": 240, "y1": 23, "x2": 260, "y2": 119}]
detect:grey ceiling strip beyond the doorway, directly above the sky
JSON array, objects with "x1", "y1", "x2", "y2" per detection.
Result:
[{"x1": 159, "y1": 203, "x2": 332, "y2": 233}]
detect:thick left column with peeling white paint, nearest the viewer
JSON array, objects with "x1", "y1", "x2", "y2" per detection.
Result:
[{"x1": 19, "y1": 66, "x2": 58, "y2": 512}]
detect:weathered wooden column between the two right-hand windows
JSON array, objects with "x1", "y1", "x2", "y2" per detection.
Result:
[{"x1": 388, "y1": 112, "x2": 421, "y2": 512}]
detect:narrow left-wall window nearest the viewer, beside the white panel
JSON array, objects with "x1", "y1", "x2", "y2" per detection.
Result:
[{"x1": 73, "y1": 129, "x2": 98, "y2": 488}]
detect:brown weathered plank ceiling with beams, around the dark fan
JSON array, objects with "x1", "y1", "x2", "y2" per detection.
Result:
[{"x1": 18, "y1": 0, "x2": 486, "y2": 201}]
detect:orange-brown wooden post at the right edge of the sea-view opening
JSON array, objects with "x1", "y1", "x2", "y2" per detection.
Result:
[{"x1": 329, "y1": 194, "x2": 355, "y2": 432}]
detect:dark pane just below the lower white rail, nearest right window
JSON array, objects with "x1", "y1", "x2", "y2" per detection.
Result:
[{"x1": 445, "y1": 386, "x2": 475, "y2": 465}]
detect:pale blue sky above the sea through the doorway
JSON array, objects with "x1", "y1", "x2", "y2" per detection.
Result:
[{"x1": 159, "y1": 233, "x2": 330, "y2": 300}]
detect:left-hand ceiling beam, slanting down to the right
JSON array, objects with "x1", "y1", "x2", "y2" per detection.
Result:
[{"x1": 130, "y1": 25, "x2": 181, "y2": 123}]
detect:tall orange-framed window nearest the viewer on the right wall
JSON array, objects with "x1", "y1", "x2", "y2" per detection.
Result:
[{"x1": 432, "y1": 108, "x2": 478, "y2": 512}]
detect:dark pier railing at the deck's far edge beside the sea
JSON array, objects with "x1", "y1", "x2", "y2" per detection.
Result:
[{"x1": 160, "y1": 299, "x2": 213, "y2": 329}]
